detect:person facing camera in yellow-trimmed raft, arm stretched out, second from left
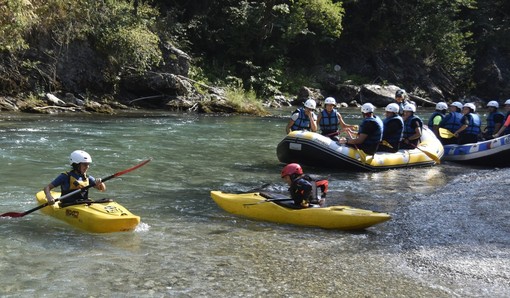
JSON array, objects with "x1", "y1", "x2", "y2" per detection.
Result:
[{"x1": 317, "y1": 97, "x2": 355, "y2": 141}]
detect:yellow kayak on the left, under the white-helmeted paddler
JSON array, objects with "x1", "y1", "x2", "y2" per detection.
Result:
[{"x1": 36, "y1": 191, "x2": 140, "y2": 233}]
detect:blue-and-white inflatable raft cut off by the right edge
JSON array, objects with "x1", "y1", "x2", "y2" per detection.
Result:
[{"x1": 443, "y1": 135, "x2": 510, "y2": 167}]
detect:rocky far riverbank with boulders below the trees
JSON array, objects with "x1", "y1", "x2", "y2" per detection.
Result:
[{"x1": 0, "y1": 36, "x2": 510, "y2": 114}]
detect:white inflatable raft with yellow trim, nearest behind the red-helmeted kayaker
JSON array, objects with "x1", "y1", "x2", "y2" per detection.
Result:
[{"x1": 276, "y1": 126, "x2": 444, "y2": 171}]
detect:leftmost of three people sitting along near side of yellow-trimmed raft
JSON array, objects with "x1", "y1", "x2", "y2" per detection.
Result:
[{"x1": 338, "y1": 103, "x2": 383, "y2": 154}]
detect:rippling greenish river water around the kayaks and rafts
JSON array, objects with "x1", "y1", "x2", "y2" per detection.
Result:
[{"x1": 0, "y1": 112, "x2": 510, "y2": 297}]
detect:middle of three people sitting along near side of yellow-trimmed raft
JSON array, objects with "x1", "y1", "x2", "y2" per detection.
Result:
[{"x1": 378, "y1": 103, "x2": 404, "y2": 153}]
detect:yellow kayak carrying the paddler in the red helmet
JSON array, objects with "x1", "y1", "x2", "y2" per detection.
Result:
[{"x1": 211, "y1": 191, "x2": 391, "y2": 230}]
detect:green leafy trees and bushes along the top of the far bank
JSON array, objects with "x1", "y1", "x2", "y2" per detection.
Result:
[{"x1": 0, "y1": 0, "x2": 510, "y2": 102}]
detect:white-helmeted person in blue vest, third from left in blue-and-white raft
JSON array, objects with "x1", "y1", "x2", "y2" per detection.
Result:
[{"x1": 453, "y1": 103, "x2": 482, "y2": 144}]
